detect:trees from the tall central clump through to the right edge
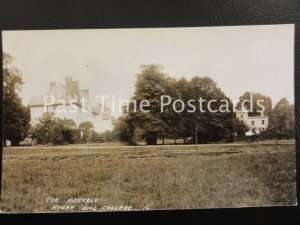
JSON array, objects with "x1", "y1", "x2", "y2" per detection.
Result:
[{"x1": 114, "y1": 65, "x2": 294, "y2": 144}]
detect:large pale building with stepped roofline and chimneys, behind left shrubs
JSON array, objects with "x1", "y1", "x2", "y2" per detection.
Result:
[{"x1": 30, "y1": 77, "x2": 112, "y2": 132}]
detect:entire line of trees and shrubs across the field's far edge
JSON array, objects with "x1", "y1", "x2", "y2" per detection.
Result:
[{"x1": 3, "y1": 53, "x2": 295, "y2": 145}]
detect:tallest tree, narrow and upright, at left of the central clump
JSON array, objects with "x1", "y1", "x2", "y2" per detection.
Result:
[{"x1": 127, "y1": 65, "x2": 169, "y2": 145}]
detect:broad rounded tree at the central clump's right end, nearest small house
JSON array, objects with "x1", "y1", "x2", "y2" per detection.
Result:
[{"x1": 187, "y1": 76, "x2": 245, "y2": 143}]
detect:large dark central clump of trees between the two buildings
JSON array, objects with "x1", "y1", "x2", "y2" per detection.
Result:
[{"x1": 114, "y1": 65, "x2": 247, "y2": 144}]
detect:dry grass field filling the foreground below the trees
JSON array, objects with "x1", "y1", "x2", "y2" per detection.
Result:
[{"x1": 1, "y1": 141, "x2": 296, "y2": 212}]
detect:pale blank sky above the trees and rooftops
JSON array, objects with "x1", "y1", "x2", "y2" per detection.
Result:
[{"x1": 2, "y1": 24, "x2": 294, "y2": 116}]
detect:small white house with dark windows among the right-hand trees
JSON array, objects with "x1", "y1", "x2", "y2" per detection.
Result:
[{"x1": 235, "y1": 110, "x2": 269, "y2": 136}]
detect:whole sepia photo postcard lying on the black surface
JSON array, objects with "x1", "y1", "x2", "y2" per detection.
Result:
[{"x1": 1, "y1": 24, "x2": 297, "y2": 213}]
